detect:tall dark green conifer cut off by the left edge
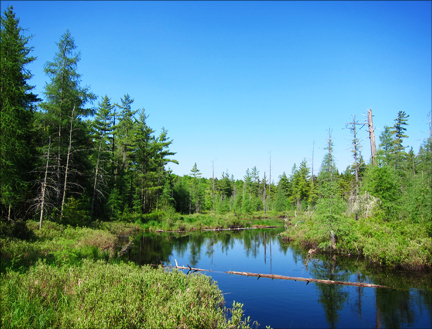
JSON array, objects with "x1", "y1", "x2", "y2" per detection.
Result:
[{"x1": 0, "y1": 6, "x2": 39, "y2": 219}]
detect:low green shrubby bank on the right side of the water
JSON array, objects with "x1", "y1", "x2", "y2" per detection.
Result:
[{"x1": 281, "y1": 213, "x2": 432, "y2": 270}]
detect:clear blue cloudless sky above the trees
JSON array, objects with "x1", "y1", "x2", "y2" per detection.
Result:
[{"x1": 1, "y1": 1, "x2": 432, "y2": 182}]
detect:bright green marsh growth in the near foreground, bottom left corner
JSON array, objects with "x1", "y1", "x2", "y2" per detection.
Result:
[{"x1": 0, "y1": 259, "x2": 255, "y2": 328}]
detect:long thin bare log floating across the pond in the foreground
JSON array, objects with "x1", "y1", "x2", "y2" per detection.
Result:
[{"x1": 150, "y1": 260, "x2": 390, "y2": 289}]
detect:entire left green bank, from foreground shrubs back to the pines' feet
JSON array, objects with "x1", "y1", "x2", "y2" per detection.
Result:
[{"x1": 0, "y1": 221, "x2": 258, "y2": 328}]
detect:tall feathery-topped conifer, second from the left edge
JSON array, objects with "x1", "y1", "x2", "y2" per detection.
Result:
[{"x1": 41, "y1": 31, "x2": 96, "y2": 217}]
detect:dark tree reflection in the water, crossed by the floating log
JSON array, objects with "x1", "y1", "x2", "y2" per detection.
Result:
[{"x1": 309, "y1": 256, "x2": 350, "y2": 328}]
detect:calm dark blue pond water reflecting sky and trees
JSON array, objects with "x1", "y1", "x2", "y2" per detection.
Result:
[{"x1": 129, "y1": 229, "x2": 432, "y2": 328}]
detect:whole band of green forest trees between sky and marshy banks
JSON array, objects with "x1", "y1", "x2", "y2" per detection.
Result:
[{"x1": 0, "y1": 7, "x2": 432, "y2": 225}]
